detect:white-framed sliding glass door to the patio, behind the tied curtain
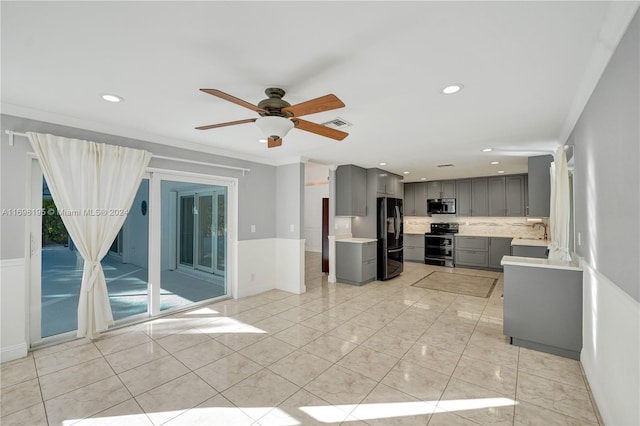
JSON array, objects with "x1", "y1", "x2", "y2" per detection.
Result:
[{"x1": 26, "y1": 159, "x2": 231, "y2": 345}]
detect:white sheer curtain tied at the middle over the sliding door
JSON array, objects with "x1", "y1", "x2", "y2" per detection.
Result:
[{"x1": 27, "y1": 132, "x2": 151, "y2": 339}]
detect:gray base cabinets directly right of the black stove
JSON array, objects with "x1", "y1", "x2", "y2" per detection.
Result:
[{"x1": 455, "y1": 236, "x2": 512, "y2": 270}]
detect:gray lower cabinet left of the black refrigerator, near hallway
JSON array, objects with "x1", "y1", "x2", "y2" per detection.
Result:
[{"x1": 336, "y1": 240, "x2": 378, "y2": 285}]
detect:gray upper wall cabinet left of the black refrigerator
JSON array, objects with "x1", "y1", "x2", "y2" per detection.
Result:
[{"x1": 336, "y1": 164, "x2": 367, "y2": 216}]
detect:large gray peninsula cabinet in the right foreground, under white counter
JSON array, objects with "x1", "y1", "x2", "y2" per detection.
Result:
[{"x1": 503, "y1": 264, "x2": 582, "y2": 359}]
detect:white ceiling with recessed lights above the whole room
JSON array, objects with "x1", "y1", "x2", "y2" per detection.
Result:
[{"x1": 1, "y1": 1, "x2": 638, "y2": 181}]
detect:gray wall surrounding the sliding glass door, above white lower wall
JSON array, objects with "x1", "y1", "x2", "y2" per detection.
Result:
[{"x1": 0, "y1": 115, "x2": 276, "y2": 259}]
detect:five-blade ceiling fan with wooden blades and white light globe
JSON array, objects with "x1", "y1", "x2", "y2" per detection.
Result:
[{"x1": 196, "y1": 87, "x2": 349, "y2": 148}]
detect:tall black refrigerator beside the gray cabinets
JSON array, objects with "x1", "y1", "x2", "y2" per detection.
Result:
[{"x1": 376, "y1": 197, "x2": 403, "y2": 281}]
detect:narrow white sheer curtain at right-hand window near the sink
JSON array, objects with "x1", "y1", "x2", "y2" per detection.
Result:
[{"x1": 549, "y1": 146, "x2": 571, "y2": 261}]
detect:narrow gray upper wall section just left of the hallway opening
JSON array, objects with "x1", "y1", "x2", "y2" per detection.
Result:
[{"x1": 276, "y1": 163, "x2": 304, "y2": 239}]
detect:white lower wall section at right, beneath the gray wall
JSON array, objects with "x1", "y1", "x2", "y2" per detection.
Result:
[{"x1": 580, "y1": 262, "x2": 640, "y2": 425}]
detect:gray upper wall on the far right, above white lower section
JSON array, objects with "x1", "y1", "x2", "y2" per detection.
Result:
[{"x1": 568, "y1": 14, "x2": 640, "y2": 301}]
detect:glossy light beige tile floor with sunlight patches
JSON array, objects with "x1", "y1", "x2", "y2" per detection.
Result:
[{"x1": 0, "y1": 254, "x2": 598, "y2": 426}]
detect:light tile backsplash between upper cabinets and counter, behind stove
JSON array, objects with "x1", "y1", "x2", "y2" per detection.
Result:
[{"x1": 404, "y1": 215, "x2": 549, "y2": 238}]
